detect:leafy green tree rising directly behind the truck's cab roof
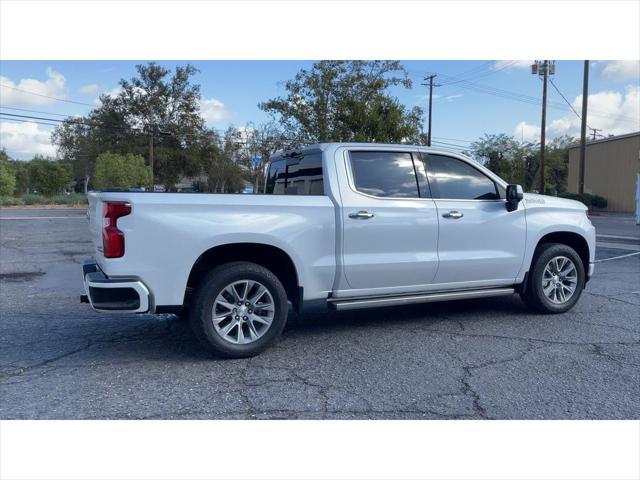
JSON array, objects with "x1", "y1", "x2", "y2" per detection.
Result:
[{"x1": 259, "y1": 60, "x2": 422, "y2": 143}]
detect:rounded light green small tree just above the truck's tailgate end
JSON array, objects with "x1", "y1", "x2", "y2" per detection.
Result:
[{"x1": 93, "y1": 152, "x2": 151, "y2": 189}]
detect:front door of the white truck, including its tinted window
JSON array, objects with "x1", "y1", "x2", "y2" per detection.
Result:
[{"x1": 423, "y1": 154, "x2": 527, "y2": 286}]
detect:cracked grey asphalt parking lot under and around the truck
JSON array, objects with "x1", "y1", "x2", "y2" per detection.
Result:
[{"x1": 0, "y1": 209, "x2": 640, "y2": 419}]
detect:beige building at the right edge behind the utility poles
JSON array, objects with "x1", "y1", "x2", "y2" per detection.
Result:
[{"x1": 567, "y1": 132, "x2": 640, "y2": 213}]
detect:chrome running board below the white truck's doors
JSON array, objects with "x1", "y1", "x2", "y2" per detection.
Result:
[{"x1": 327, "y1": 287, "x2": 515, "y2": 310}]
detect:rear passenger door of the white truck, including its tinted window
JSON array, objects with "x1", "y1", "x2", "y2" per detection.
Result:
[{"x1": 340, "y1": 151, "x2": 438, "y2": 290}]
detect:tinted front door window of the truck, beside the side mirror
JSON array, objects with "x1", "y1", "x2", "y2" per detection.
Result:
[{"x1": 427, "y1": 155, "x2": 500, "y2": 200}]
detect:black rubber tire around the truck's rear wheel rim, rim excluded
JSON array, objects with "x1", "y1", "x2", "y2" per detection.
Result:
[{"x1": 189, "y1": 262, "x2": 288, "y2": 358}]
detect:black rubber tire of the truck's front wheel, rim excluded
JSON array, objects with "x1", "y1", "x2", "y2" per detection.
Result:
[{"x1": 520, "y1": 243, "x2": 585, "y2": 313}]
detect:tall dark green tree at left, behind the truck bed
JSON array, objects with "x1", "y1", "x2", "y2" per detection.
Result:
[{"x1": 52, "y1": 62, "x2": 204, "y2": 188}]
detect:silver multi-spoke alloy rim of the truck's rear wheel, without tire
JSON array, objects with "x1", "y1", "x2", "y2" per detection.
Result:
[{"x1": 211, "y1": 280, "x2": 275, "y2": 345}]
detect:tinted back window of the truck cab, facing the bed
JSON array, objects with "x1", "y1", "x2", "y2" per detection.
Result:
[{"x1": 264, "y1": 152, "x2": 324, "y2": 195}]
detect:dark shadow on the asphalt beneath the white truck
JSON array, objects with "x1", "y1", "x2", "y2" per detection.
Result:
[{"x1": 47, "y1": 296, "x2": 531, "y2": 362}]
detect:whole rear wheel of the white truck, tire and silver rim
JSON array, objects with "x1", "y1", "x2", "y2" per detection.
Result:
[{"x1": 189, "y1": 262, "x2": 288, "y2": 358}]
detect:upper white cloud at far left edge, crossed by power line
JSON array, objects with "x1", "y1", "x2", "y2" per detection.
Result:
[{"x1": 0, "y1": 67, "x2": 66, "y2": 106}]
